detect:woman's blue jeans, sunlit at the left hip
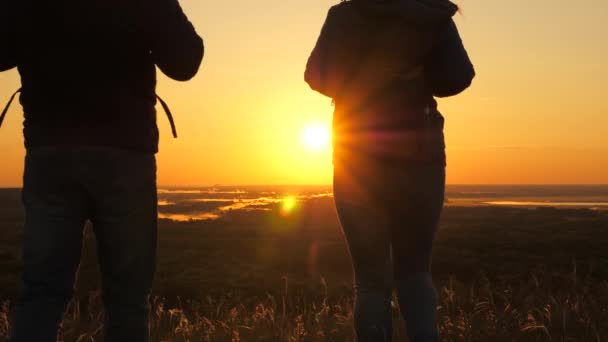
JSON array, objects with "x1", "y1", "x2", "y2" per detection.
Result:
[{"x1": 334, "y1": 161, "x2": 445, "y2": 342}]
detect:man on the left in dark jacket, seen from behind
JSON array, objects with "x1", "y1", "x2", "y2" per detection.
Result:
[{"x1": 0, "y1": 0, "x2": 204, "y2": 342}]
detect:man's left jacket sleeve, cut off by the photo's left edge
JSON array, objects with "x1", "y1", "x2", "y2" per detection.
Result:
[{"x1": 0, "y1": 0, "x2": 19, "y2": 72}]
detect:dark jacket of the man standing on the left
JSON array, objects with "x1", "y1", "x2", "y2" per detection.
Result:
[{"x1": 0, "y1": 0, "x2": 204, "y2": 152}]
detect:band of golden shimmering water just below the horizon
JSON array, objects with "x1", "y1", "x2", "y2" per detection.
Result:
[{"x1": 158, "y1": 186, "x2": 608, "y2": 221}]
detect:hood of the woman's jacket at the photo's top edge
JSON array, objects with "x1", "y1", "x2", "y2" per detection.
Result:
[{"x1": 351, "y1": 0, "x2": 458, "y2": 26}]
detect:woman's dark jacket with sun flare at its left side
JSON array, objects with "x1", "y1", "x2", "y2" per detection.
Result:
[{"x1": 304, "y1": 0, "x2": 475, "y2": 162}]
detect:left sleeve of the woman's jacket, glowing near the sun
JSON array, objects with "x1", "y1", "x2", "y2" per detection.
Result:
[{"x1": 304, "y1": 8, "x2": 335, "y2": 97}]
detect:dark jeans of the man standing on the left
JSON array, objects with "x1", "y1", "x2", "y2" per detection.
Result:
[{"x1": 11, "y1": 147, "x2": 157, "y2": 342}]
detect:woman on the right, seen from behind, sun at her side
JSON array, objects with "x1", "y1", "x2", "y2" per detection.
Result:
[{"x1": 305, "y1": 0, "x2": 475, "y2": 342}]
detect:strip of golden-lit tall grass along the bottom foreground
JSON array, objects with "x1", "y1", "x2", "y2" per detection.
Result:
[{"x1": 0, "y1": 271, "x2": 608, "y2": 341}]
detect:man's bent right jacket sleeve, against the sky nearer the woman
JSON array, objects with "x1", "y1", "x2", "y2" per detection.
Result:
[{"x1": 149, "y1": 0, "x2": 205, "y2": 81}]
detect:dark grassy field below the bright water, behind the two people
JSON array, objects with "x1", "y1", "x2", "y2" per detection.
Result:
[{"x1": 0, "y1": 191, "x2": 608, "y2": 341}]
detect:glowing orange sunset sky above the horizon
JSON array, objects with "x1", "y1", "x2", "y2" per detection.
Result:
[{"x1": 0, "y1": 0, "x2": 608, "y2": 187}]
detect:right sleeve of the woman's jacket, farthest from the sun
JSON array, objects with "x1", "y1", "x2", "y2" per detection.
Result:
[{"x1": 426, "y1": 20, "x2": 475, "y2": 97}]
